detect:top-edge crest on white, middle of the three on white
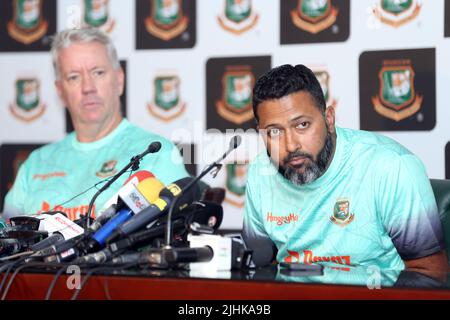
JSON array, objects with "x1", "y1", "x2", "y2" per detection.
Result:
[{"x1": 217, "y1": 0, "x2": 259, "y2": 35}]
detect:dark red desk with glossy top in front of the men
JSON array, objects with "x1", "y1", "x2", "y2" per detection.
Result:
[{"x1": 2, "y1": 267, "x2": 450, "y2": 300}]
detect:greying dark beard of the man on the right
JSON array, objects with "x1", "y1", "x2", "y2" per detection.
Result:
[{"x1": 278, "y1": 131, "x2": 334, "y2": 185}]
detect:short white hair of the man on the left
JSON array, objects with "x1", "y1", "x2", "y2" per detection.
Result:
[{"x1": 50, "y1": 27, "x2": 120, "y2": 79}]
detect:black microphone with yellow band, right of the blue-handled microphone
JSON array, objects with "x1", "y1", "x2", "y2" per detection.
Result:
[{"x1": 106, "y1": 177, "x2": 200, "y2": 243}]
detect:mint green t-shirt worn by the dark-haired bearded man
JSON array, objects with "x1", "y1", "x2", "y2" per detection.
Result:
[{"x1": 244, "y1": 128, "x2": 444, "y2": 269}]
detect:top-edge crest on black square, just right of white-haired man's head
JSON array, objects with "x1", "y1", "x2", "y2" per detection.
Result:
[{"x1": 145, "y1": 0, "x2": 189, "y2": 41}]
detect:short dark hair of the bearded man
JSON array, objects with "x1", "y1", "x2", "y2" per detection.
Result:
[{"x1": 253, "y1": 64, "x2": 326, "y2": 122}]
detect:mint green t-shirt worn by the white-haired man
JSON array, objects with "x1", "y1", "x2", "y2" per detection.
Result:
[{"x1": 3, "y1": 119, "x2": 188, "y2": 220}]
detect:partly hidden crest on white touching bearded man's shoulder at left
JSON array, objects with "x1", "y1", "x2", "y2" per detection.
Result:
[{"x1": 225, "y1": 163, "x2": 248, "y2": 208}]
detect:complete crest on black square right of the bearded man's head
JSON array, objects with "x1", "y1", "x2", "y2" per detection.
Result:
[{"x1": 372, "y1": 60, "x2": 423, "y2": 122}]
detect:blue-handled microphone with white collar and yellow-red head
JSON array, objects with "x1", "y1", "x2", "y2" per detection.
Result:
[{"x1": 86, "y1": 178, "x2": 164, "y2": 252}]
